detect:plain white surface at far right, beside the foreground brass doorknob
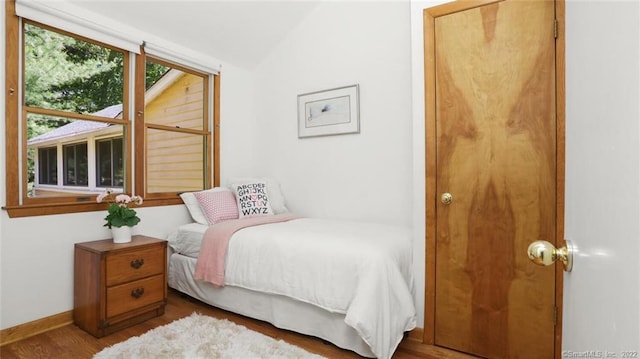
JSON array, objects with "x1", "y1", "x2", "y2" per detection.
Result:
[{"x1": 562, "y1": 1, "x2": 640, "y2": 352}]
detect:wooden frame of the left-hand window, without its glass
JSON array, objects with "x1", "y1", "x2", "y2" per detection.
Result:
[{"x1": 3, "y1": 9, "x2": 131, "y2": 218}]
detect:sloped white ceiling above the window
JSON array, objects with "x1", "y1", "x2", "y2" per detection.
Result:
[{"x1": 70, "y1": 0, "x2": 318, "y2": 69}]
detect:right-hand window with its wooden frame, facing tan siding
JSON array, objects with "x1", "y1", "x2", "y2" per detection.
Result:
[{"x1": 135, "y1": 56, "x2": 220, "y2": 203}]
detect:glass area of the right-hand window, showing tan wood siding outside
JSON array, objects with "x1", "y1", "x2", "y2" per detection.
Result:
[{"x1": 144, "y1": 57, "x2": 210, "y2": 198}]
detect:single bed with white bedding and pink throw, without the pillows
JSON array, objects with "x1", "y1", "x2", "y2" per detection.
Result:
[{"x1": 168, "y1": 183, "x2": 416, "y2": 358}]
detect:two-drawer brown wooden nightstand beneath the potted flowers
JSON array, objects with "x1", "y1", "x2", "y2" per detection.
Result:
[{"x1": 73, "y1": 235, "x2": 167, "y2": 338}]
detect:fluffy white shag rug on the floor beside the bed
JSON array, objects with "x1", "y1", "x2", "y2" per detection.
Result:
[{"x1": 93, "y1": 313, "x2": 323, "y2": 359}]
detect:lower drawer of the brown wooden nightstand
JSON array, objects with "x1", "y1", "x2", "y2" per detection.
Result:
[{"x1": 107, "y1": 274, "x2": 164, "y2": 318}]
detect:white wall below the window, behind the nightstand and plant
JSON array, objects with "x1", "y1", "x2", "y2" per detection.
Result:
[{"x1": 0, "y1": 207, "x2": 189, "y2": 329}]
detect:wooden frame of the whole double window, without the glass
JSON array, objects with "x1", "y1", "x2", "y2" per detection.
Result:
[{"x1": 2, "y1": 0, "x2": 220, "y2": 218}]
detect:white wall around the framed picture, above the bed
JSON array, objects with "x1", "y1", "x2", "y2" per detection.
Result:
[{"x1": 254, "y1": 1, "x2": 412, "y2": 227}]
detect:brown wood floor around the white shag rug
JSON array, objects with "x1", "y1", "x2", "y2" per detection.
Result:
[{"x1": 0, "y1": 290, "x2": 436, "y2": 359}]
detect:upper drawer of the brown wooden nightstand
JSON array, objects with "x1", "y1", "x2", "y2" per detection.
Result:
[{"x1": 106, "y1": 245, "x2": 166, "y2": 286}]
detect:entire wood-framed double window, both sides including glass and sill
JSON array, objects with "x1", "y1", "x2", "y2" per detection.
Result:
[{"x1": 4, "y1": 0, "x2": 219, "y2": 217}]
